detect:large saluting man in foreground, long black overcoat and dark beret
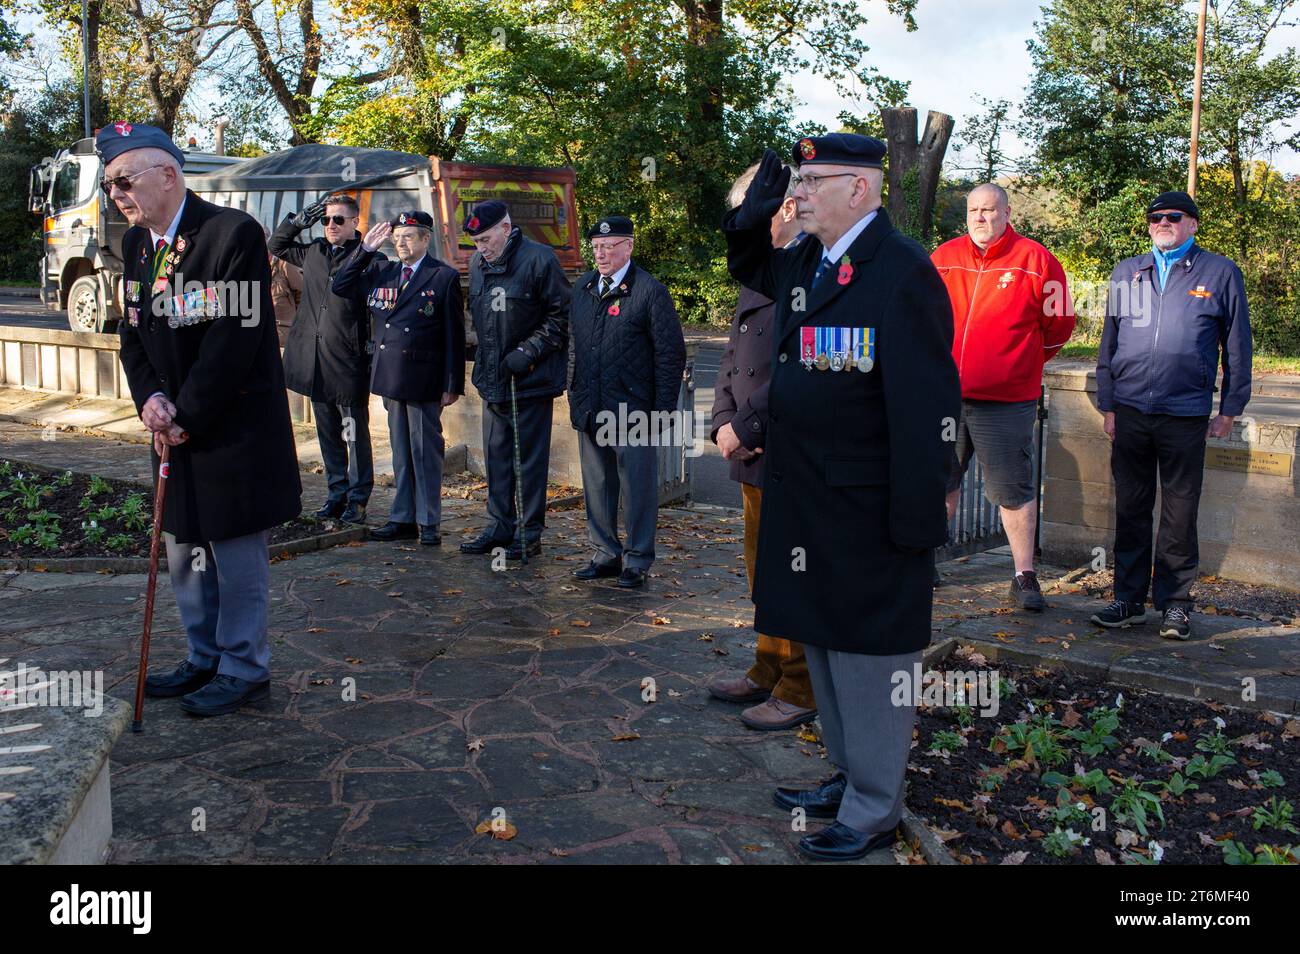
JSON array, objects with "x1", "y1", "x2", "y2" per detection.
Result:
[{"x1": 723, "y1": 134, "x2": 961, "y2": 860}]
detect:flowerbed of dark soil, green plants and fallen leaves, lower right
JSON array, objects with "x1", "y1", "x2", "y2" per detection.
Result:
[{"x1": 909, "y1": 652, "x2": 1300, "y2": 864}]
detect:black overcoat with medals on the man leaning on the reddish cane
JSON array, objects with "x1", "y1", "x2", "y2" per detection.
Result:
[{"x1": 118, "y1": 192, "x2": 302, "y2": 543}]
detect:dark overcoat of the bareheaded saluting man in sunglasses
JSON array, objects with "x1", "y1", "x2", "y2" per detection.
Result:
[{"x1": 267, "y1": 216, "x2": 386, "y2": 404}]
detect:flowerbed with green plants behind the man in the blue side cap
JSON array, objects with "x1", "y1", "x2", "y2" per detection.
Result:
[{"x1": 0, "y1": 460, "x2": 351, "y2": 559}]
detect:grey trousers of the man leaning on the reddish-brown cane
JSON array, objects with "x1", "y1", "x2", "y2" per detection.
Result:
[{"x1": 163, "y1": 530, "x2": 270, "y2": 682}]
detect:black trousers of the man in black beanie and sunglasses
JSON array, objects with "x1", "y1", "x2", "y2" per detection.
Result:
[{"x1": 1110, "y1": 404, "x2": 1209, "y2": 612}]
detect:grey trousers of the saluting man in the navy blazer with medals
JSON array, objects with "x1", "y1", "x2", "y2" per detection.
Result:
[{"x1": 384, "y1": 398, "x2": 446, "y2": 526}]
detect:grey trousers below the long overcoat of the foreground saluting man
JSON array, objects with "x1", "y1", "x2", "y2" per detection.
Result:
[{"x1": 803, "y1": 643, "x2": 920, "y2": 833}]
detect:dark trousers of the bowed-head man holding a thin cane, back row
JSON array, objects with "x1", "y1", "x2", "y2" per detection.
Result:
[{"x1": 484, "y1": 398, "x2": 555, "y2": 542}]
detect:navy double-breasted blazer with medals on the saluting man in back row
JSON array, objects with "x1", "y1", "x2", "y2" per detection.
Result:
[{"x1": 334, "y1": 243, "x2": 465, "y2": 403}]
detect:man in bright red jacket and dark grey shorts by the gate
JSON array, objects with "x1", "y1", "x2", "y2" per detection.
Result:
[{"x1": 931, "y1": 183, "x2": 1074, "y2": 611}]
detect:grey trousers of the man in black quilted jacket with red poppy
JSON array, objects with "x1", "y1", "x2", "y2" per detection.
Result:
[{"x1": 577, "y1": 430, "x2": 659, "y2": 569}]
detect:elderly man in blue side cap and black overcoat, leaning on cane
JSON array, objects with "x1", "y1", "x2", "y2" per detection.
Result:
[{"x1": 95, "y1": 122, "x2": 302, "y2": 716}]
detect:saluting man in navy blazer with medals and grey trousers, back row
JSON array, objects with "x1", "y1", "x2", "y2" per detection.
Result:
[{"x1": 333, "y1": 211, "x2": 465, "y2": 546}]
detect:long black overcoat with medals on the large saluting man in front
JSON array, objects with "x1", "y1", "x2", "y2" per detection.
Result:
[{"x1": 724, "y1": 209, "x2": 961, "y2": 655}]
